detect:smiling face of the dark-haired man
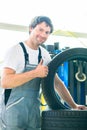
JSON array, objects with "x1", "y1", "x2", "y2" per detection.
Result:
[{"x1": 29, "y1": 22, "x2": 51, "y2": 47}]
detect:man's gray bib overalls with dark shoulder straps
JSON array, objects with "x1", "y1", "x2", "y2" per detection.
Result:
[{"x1": 2, "y1": 44, "x2": 41, "y2": 130}]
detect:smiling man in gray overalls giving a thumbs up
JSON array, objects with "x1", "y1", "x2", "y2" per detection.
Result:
[{"x1": 1, "y1": 16, "x2": 85, "y2": 130}]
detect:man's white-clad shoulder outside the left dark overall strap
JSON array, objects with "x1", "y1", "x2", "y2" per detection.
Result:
[{"x1": 3, "y1": 44, "x2": 24, "y2": 72}]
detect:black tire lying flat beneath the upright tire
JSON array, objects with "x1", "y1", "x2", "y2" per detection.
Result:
[{"x1": 41, "y1": 109, "x2": 87, "y2": 130}]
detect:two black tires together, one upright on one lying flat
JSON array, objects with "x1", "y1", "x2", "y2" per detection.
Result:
[{"x1": 41, "y1": 48, "x2": 87, "y2": 130}]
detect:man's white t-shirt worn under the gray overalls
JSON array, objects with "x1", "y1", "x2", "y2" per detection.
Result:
[{"x1": 3, "y1": 43, "x2": 51, "y2": 73}]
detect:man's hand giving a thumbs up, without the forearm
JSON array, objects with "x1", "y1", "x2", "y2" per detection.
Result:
[{"x1": 36, "y1": 59, "x2": 48, "y2": 78}]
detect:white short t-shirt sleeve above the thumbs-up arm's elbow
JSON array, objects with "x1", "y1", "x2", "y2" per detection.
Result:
[{"x1": 3, "y1": 45, "x2": 22, "y2": 71}]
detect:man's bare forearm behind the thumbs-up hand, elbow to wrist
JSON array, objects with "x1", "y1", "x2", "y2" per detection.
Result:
[{"x1": 1, "y1": 70, "x2": 38, "y2": 88}]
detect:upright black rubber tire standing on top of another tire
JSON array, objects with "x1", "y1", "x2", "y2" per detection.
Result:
[{"x1": 42, "y1": 48, "x2": 87, "y2": 110}]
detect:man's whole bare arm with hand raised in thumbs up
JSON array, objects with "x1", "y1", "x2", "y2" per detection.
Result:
[{"x1": 1, "y1": 60, "x2": 48, "y2": 88}]
